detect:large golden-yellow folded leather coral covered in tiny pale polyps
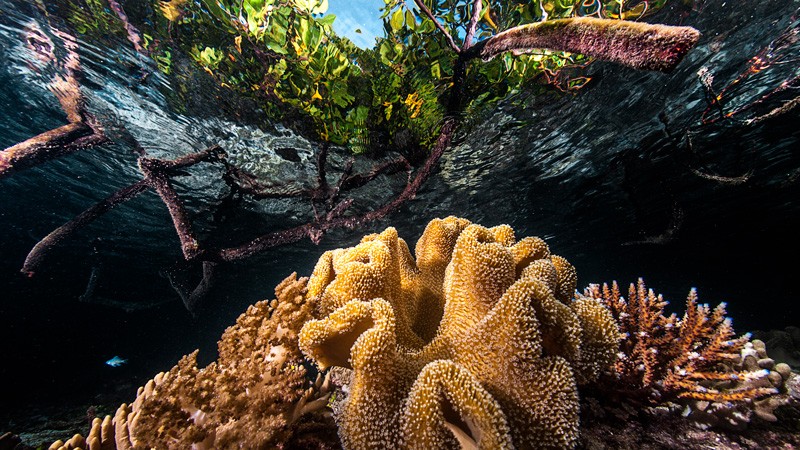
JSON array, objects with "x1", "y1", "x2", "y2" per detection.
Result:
[{"x1": 300, "y1": 217, "x2": 619, "y2": 449}]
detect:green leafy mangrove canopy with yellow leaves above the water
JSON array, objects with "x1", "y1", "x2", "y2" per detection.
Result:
[{"x1": 72, "y1": 0, "x2": 666, "y2": 153}]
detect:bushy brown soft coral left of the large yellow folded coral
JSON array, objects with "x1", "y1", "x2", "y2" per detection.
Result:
[{"x1": 51, "y1": 274, "x2": 338, "y2": 450}]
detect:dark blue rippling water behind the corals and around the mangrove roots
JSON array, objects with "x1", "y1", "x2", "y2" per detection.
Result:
[{"x1": 0, "y1": 0, "x2": 800, "y2": 448}]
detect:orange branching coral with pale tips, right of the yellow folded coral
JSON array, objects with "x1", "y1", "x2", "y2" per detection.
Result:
[{"x1": 584, "y1": 279, "x2": 776, "y2": 403}]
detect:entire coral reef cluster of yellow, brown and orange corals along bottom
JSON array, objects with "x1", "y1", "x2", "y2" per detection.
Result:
[{"x1": 39, "y1": 217, "x2": 800, "y2": 450}]
